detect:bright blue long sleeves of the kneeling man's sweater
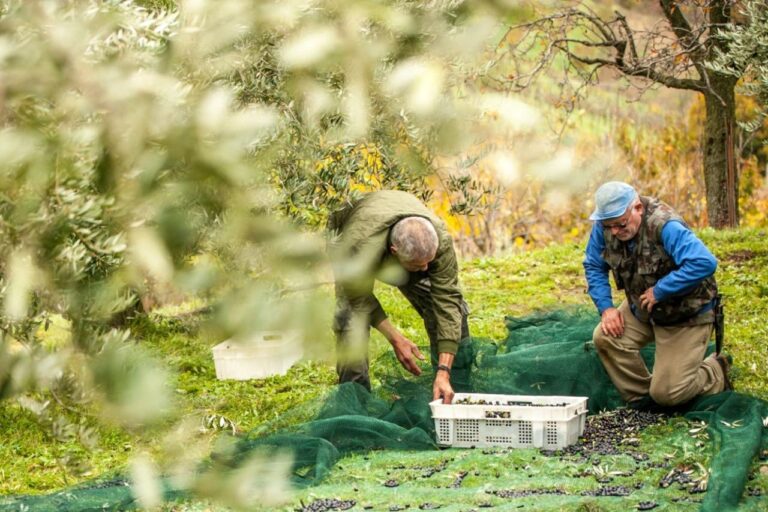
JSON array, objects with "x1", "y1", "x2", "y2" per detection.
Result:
[{"x1": 584, "y1": 220, "x2": 717, "y2": 315}]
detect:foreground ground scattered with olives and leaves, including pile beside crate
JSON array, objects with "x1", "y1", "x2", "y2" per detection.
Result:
[{"x1": 285, "y1": 409, "x2": 768, "y2": 511}]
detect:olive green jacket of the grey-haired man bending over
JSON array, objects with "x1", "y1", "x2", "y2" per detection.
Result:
[{"x1": 328, "y1": 190, "x2": 462, "y2": 354}]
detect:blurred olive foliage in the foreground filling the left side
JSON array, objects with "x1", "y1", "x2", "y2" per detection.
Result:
[{"x1": 0, "y1": 0, "x2": 556, "y2": 507}]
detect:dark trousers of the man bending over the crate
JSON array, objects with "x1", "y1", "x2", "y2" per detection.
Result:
[{"x1": 334, "y1": 277, "x2": 469, "y2": 391}]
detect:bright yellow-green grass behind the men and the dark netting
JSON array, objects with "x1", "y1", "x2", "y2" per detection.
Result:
[{"x1": 0, "y1": 230, "x2": 768, "y2": 510}]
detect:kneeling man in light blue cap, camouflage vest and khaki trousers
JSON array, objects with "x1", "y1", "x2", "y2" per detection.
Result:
[{"x1": 584, "y1": 181, "x2": 731, "y2": 406}]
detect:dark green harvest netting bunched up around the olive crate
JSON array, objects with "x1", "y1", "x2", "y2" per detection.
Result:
[{"x1": 0, "y1": 309, "x2": 768, "y2": 512}]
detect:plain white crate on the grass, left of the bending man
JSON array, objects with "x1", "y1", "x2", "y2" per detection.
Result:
[{"x1": 211, "y1": 331, "x2": 303, "y2": 380}]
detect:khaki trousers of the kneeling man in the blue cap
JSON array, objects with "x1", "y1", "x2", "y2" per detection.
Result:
[{"x1": 592, "y1": 300, "x2": 725, "y2": 406}]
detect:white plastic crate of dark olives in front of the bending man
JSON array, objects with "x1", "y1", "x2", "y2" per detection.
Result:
[{"x1": 429, "y1": 393, "x2": 587, "y2": 450}]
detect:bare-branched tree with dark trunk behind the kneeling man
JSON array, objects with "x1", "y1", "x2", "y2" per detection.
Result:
[{"x1": 498, "y1": 0, "x2": 748, "y2": 228}]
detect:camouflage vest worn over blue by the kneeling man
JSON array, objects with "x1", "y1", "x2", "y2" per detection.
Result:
[{"x1": 603, "y1": 197, "x2": 717, "y2": 325}]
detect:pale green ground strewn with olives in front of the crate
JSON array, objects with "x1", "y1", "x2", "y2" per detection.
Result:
[{"x1": 272, "y1": 418, "x2": 768, "y2": 512}]
